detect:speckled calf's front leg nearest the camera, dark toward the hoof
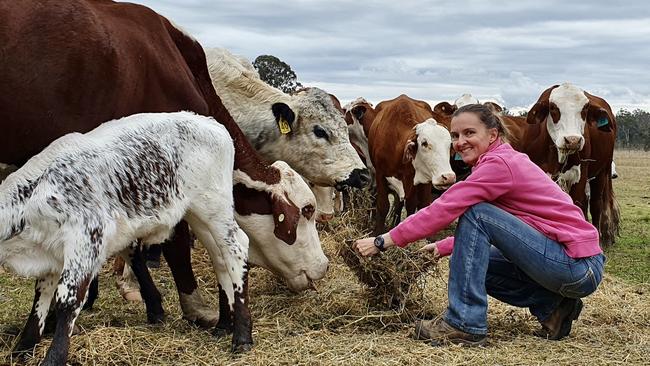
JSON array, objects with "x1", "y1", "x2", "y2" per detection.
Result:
[{"x1": 41, "y1": 258, "x2": 100, "y2": 366}]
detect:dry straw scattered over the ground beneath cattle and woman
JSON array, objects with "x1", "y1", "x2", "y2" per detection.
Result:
[{"x1": 0, "y1": 187, "x2": 650, "y2": 366}]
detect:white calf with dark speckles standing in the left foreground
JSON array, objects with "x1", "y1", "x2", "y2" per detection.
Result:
[{"x1": 0, "y1": 112, "x2": 252, "y2": 365}]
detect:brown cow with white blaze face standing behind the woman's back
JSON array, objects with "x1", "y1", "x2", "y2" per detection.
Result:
[{"x1": 521, "y1": 83, "x2": 619, "y2": 245}]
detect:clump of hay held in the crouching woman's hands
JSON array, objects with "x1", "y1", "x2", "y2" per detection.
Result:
[{"x1": 339, "y1": 240, "x2": 435, "y2": 315}]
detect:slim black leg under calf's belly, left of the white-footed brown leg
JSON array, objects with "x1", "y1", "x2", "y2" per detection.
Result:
[{"x1": 122, "y1": 242, "x2": 165, "y2": 324}]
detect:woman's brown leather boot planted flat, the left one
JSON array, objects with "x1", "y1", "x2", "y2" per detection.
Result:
[{"x1": 413, "y1": 318, "x2": 487, "y2": 347}]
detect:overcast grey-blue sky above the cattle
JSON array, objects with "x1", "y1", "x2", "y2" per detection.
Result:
[{"x1": 133, "y1": 0, "x2": 650, "y2": 112}]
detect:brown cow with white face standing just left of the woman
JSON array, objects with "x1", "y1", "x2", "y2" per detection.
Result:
[{"x1": 368, "y1": 95, "x2": 456, "y2": 234}]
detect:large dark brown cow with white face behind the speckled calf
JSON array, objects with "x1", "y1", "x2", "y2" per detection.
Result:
[{"x1": 0, "y1": 0, "x2": 326, "y2": 353}]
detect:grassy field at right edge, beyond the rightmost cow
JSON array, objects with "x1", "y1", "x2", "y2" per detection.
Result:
[{"x1": 605, "y1": 150, "x2": 650, "y2": 284}]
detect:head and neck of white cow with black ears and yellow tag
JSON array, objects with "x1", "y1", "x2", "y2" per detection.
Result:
[{"x1": 206, "y1": 48, "x2": 369, "y2": 189}]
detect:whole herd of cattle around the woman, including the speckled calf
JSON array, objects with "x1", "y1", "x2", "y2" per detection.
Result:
[{"x1": 0, "y1": 0, "x2": 619, "y2": 365}]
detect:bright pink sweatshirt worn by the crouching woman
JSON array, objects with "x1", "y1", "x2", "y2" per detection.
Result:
[{"x1": 389, "y1": 139, "x2": 602, "y2": 258}]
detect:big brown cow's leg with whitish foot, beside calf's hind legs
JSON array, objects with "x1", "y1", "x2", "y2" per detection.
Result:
[{"x1": 162, "y1": 221, "x2": 219, "y2": 328}]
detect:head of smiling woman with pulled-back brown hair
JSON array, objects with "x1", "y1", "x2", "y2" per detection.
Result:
[{"x1": 451, "y1": 112, "x2": 498, "y2": 166}]
